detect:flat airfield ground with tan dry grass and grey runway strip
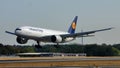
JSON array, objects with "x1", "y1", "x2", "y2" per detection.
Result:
[{"x1": 0, "y1": 57, "x2": 120, "y2": 68}]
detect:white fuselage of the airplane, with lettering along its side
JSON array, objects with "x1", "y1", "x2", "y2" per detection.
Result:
[{"x1": 15, "y1": 26, "x2": 74, "y2": 42}]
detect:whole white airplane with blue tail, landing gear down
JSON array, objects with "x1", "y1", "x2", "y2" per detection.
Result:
[{"x1": 5, "y1": 16, "x2": 112, "y2": 48}]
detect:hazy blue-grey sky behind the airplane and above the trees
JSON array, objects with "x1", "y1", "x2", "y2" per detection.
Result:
[{"x1": 0, "y1": 0, "x2": 120, "y2": 44}]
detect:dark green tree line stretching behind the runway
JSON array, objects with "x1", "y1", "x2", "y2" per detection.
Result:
[{"x1": 0, "y1": 43, "x2": 120, "y2": 56}]
